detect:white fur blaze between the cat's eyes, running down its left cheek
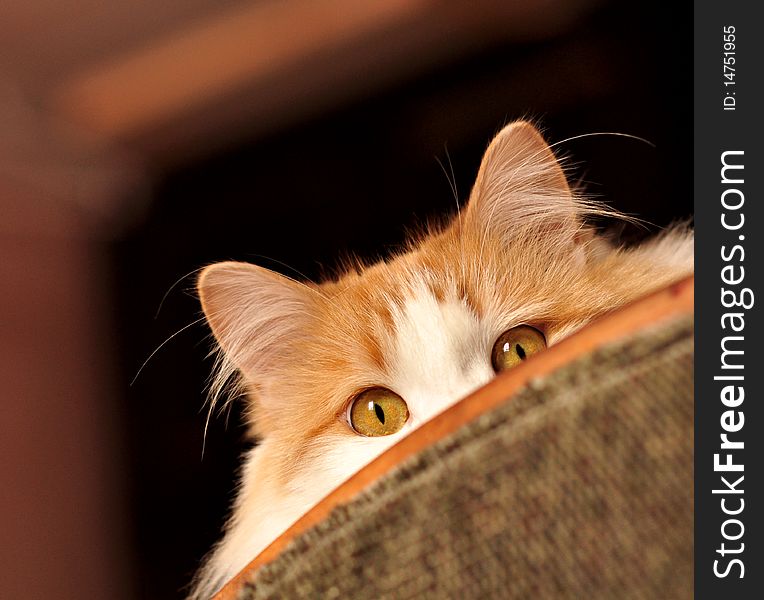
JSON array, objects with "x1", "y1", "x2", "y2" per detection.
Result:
[{"x1": 289, "y1": 285, "x2": 495, "y2": 552}]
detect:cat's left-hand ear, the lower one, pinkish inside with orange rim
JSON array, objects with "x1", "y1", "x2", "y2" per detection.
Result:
[{"x1": 197, "y1": 262, "x2": 319, "y2": 376}]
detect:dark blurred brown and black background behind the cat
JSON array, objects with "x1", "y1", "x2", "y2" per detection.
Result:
[{"x1": 0, "y1": 0, "x2": 692, "y2": 599}]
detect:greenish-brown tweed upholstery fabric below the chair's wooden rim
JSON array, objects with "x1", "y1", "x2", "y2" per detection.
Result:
[{"x1": 239, "y1": 319, "x2": 693, "y2": 600}]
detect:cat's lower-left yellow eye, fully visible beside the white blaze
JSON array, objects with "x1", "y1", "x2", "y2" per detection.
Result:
[{"x1": 349, "y1": 387, "x2": 409, "y2": 437}]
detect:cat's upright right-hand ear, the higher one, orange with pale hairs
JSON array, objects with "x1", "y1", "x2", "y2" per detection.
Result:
[{"x1": 466, "y1": 121, "x2": 579, "y2": 237}]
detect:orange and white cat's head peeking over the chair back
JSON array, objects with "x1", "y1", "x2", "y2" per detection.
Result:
[{"x1": 198, "y1": 121, "x2": 688, "y2": 492}]
